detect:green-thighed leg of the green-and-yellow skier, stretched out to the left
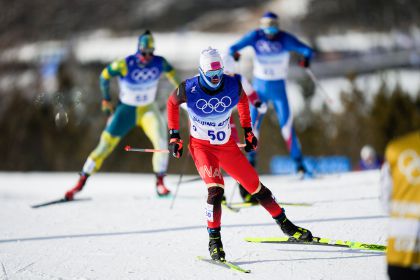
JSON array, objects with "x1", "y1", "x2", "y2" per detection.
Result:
[{"x1": 65, "y1": 104, "x2": 135, "y2": 200}]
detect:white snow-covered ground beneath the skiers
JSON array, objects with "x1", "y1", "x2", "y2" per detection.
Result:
[{"x1": 0, "y1": 171, "x2": 388, "y2": 280}]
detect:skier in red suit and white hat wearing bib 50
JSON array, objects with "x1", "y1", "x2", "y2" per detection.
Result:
[{"x1": 167, "y1": 47, "x2": 312, "y2": 260}]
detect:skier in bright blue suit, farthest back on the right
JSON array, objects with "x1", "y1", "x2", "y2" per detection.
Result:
[{"x1": 229, "y1": 12, "x2": 313, "y2": 179}]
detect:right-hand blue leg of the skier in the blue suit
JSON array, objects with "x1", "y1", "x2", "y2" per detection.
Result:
[{"x1": 272, "y1": 81, "x2": 306, "y2": 172}]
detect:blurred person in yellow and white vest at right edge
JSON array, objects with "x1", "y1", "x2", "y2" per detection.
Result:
[{"x1": 381, "y1": 130, "x2": 420, "y2": 279}]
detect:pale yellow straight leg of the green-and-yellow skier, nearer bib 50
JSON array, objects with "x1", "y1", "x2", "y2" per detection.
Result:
[{"x1": 137, "y1": 103, "x2": 170, "y2": 196}]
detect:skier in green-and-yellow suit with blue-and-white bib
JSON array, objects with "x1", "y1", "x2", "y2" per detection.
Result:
[{"x1": 65, "y1": 30, "x2": 179, "y2": 200}]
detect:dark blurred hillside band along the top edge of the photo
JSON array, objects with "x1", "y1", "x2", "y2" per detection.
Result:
[{"x1": 0, "y1": 0, "x2": 420, "y2": 48}]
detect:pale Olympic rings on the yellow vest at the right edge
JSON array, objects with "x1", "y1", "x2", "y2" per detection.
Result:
[{"x1": 398, "y1": 150, "x2": 420, "y2": 185}]
